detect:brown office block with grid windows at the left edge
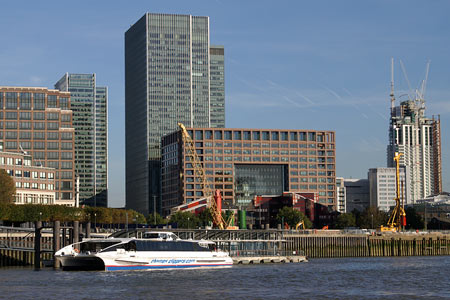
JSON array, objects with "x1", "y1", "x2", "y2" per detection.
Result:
[{"x1": 0, "y1": 87, "x2": 76, "y2": 206}]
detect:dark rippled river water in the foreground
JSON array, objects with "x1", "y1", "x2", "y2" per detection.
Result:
[{"x1": 0, "y1": 256, "x2": 450, "y2": 300}]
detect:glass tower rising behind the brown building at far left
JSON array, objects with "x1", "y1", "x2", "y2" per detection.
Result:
[{"x1": 55, "y1": 73, "x2": 108, "y2": 207}]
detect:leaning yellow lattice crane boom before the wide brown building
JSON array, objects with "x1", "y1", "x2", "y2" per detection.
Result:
[{"x1": 178, "y1": 123, "x2": 228, "y2": 229}]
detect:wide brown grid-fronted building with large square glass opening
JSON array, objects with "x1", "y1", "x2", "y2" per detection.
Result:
[{"x1": 161, "y1": 128, "x2": 337, "y2": 214}]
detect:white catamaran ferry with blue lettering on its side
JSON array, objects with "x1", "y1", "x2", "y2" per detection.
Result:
[{"x1": 55, "y1": 232, "x2": 233, "y2": 271}]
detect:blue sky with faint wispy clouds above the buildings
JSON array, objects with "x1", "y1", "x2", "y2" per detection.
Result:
[{"x1": 0, "y1": 0, "x2": 450, "y2": 207}]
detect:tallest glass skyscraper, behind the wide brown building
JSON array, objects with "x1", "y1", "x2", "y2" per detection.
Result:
[{"x1": 125, "y1": 13, "x2": 225, "y2": 213}]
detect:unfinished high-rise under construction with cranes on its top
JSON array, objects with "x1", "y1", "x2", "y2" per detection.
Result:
[{"x1": 387, "y1": 100, "x2": 442, "y2": 203}]
